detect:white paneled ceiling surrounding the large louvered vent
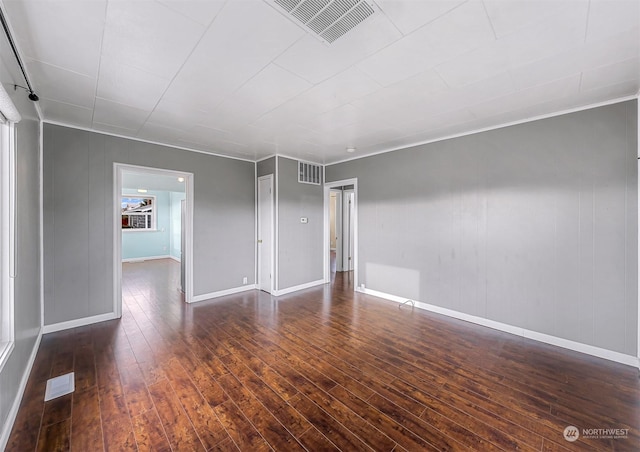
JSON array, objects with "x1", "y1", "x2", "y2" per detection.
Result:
[{"x1": 2, "y1": 0, "x2": 640, "y2": 163}]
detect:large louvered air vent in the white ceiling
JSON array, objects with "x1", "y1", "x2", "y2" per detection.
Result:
[{"x1": 267, "y1": 0, "x2": 374, "y2": 44}]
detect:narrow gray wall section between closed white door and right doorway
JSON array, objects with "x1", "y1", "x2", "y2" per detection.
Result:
[{"x1": 276, "y1": 157, "x2": 324, "y2": 290}]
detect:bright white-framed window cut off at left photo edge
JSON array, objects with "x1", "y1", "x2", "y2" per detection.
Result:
[{"x1": 0, "y1": 121, "x2": 17, "y2": 371}]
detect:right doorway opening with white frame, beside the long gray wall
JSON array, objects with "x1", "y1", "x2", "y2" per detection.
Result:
[{"x1": 324, "y1": 179, "x2": 357, "y2": 287}]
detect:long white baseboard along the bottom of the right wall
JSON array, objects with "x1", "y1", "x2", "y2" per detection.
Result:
[{"x1": 356, "y1": 287, "x2": 640, "y2": 367}]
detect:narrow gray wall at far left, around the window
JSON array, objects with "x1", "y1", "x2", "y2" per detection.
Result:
[{"x1": 0, "y1": 86, "x2": 42, "y2": 440}]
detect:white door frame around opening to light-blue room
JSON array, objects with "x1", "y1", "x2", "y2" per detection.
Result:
[{"x1": 112, "y1": 162, "x2": 193, "y2": 318}]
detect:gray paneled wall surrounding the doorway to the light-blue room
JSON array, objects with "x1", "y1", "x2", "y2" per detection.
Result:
[{"x1": 43, "y1": 124, "x2": 255, "y2": 325}]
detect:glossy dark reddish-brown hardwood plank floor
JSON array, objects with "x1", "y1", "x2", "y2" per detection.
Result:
[{"x1": 8, "y1": 260, "x2": 640, "y2": 451}]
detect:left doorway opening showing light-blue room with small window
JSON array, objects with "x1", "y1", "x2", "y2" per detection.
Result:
[{"x1": 113, "y1": 163, "x2": 193, "y2": 317}]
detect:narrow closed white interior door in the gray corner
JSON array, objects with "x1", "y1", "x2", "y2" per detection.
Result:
[{"x1": 258, "y1": 174, "x2": 273, "y2": 293}]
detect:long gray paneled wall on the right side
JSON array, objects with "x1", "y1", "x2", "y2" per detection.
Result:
[{"x1": 326, "y1": 101, "x2": 638, "y2": 356}]
